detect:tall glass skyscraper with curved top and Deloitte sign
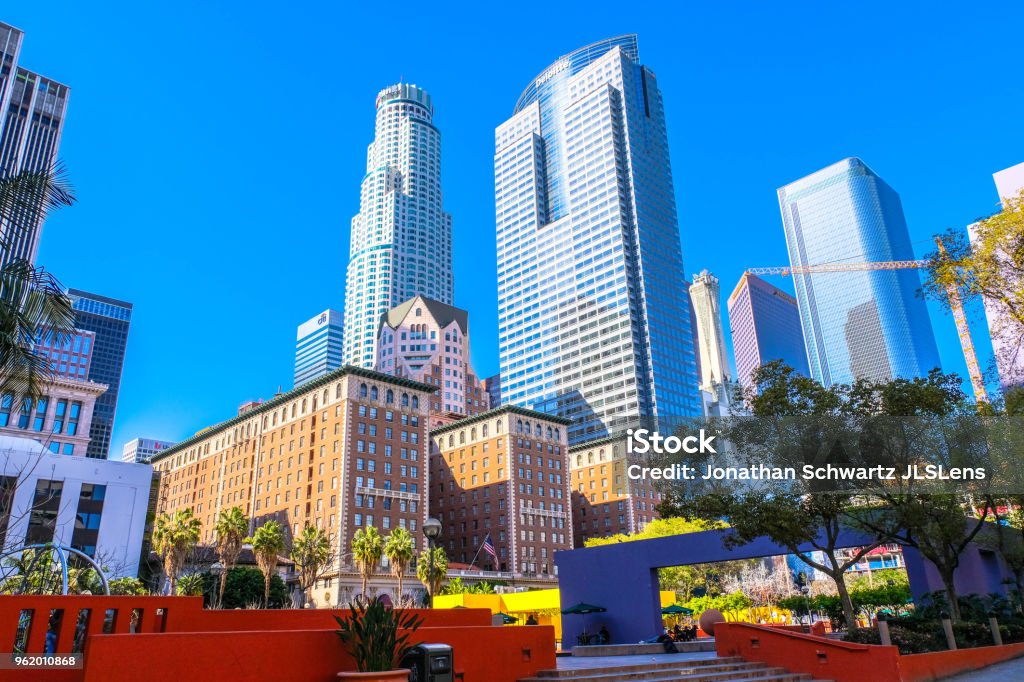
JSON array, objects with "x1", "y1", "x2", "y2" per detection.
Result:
[{"x1": 495, "y1": 35, "x2": 700, "y2": 442}]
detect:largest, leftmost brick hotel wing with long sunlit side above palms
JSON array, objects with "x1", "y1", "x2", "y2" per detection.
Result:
[{"x1": 152, "y1": 367, "x2": 434, "y2": 573}]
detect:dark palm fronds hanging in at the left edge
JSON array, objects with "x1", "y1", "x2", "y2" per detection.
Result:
[{"x1": 0, "y1": 167, "x2": 75, "y2": 401}]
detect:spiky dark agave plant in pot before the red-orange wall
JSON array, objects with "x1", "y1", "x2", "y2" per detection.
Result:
[{"x1": 335, "y1": 599, "x2": 423, "y2": 682}]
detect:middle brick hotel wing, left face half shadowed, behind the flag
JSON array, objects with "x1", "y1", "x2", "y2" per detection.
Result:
[{"x1": 430, "y1": 406, "x2": 573, "y2": 577}]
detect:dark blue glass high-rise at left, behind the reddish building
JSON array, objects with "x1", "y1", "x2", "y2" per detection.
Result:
[{"x1": 68, "y1": 289, "x2": 131, "y2": 459}]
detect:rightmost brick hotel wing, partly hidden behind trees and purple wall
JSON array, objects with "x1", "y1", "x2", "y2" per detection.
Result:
[{"x1": 568, "y1": 437, "x2": 662, "y2": 547}]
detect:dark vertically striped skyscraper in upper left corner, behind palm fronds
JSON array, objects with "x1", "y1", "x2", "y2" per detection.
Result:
[{"x1": 0, "y1": 23, "x2": 70, "y2": 266}]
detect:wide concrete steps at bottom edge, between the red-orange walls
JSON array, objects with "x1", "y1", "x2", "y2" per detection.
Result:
[{"x1": 519, "y1": 656, "x2": 826, "y2": 682}]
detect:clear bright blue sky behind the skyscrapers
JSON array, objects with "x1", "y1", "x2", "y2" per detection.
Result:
[{"x1": 8, "y1": 0, "x2": 1024, "y2": 456}]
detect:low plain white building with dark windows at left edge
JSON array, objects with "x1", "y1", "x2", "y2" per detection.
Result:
[{"x1": 0, "y1": 434, "x2": 153, "y2": 578}]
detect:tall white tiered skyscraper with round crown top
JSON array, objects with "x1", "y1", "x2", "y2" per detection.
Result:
[{"x1": 344, "y1": 83, "x2": 454, "y2": 369}]
